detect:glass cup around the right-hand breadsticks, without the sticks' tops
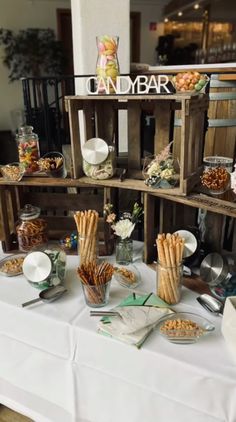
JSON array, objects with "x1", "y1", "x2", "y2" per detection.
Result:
[{"x1": 157, "y1": 261, "x2": 183, "y2": 305}]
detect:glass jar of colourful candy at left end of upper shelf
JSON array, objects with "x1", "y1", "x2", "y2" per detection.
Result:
[{"x1": 16, "y1": 126, "x2": 40, "y2": 173}]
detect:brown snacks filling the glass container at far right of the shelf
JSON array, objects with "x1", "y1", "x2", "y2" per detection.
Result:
[{"x1": 200, "y1": 166, "x2": 230, "y2": 195}]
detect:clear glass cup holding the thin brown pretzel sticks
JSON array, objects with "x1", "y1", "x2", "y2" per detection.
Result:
[{"x1": 81, "y1": 280, "x2": 111, "y2": 308}]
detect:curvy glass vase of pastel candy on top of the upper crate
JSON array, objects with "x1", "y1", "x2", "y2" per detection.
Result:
[{"x1": 96, "y1": 35, "x2": 120, "y2": 94}]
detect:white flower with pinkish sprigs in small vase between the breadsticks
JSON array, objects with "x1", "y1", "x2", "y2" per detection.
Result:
[{"x1": 104, "y1": 202, "x2": 143, "y2": 240}]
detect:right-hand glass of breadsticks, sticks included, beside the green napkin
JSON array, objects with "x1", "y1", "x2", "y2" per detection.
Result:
[{"x1": 156, "y1": 233, "x2": 184, "y2": 305}]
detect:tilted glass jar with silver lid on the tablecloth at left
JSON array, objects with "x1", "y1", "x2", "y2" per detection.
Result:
[{"x1": 23, "y1": 243, "x2": 66, "y2": 289}]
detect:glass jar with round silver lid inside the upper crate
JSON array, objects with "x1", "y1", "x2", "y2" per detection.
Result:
[{"x1": 82, "y1": 138, "x2": 116, "y2": 180}]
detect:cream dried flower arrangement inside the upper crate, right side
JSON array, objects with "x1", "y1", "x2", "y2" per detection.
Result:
[{"x1": 143, "y1": 142, "x2": 179, "y2": 189}]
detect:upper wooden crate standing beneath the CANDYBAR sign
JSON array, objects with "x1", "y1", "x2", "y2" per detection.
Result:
[{"x1": 65, "y1": 94, "x2": 209, "y2": 195}]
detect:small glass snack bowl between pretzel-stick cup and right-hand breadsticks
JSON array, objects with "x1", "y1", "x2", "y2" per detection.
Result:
[{"x1": 114, "y1": 265, "x2": 141, "y2": 289}]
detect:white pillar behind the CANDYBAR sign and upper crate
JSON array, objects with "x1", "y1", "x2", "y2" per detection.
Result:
[{"x1": 71, "y1": 0, "x2": 130, "y2": 151}]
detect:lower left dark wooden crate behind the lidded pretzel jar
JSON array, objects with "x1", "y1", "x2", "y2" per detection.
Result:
[{"x1": 0, "y1": 180, "x2": 116, "y2": 255}]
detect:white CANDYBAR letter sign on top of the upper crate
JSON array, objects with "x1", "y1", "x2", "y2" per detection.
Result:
[{"x1": 86, "y1": 75, "x2": 171, "y2": 95}]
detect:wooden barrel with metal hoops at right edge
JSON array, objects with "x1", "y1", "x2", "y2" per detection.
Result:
[{"x1": 204, "y1": 75, "x2": 236, "y2": 159}]
